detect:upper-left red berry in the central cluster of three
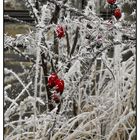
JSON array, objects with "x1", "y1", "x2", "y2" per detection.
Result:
[{"x1": 48, "y1": 73, "x2": 58, "y2": 88}]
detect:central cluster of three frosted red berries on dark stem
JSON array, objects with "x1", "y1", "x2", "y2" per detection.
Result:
[{"x1": 48, "y1": 73, "x2": 64, "y2": 103}]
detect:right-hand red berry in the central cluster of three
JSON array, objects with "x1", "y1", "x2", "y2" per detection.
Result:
[{"x1": 55, "y1": 79, "x2": 64, "y2": 94}]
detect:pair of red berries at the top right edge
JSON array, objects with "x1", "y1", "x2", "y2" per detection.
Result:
[{"x1": 107, "y1": 0, "x2": 122, "y2": 20}]
